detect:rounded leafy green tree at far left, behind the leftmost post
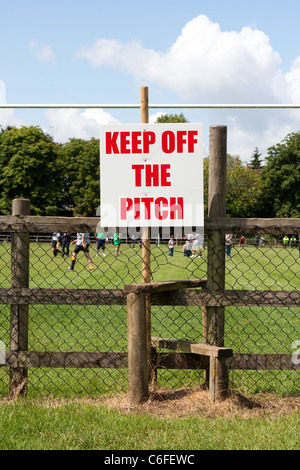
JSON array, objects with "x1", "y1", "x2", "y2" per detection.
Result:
[{"x1": 0, "y1": 126, "x2": 62, "y2": 215}]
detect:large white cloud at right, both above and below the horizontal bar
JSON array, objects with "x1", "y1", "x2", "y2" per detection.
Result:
[{"x1": 77, "y1": 15, "x2": 300, "y2": 161}]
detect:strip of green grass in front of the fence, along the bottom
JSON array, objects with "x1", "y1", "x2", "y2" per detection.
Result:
[{"x1": 0, "y1": 400, "x2": 300, "y2": 450}]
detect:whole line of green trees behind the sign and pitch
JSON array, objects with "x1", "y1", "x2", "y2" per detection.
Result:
[{"x1": 0, "y1": 119, "x2": 300, "y2": 218}]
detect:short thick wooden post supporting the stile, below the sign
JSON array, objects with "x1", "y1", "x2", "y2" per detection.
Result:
[{"x1": 127, "y1": 293, "x2": 149, "y2": 406}]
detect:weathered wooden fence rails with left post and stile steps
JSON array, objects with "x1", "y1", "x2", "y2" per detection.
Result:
[{"x1": 0, "y1": 196, "x2": 300, "y2": 403}]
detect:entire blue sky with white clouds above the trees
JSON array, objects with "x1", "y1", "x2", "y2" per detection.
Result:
[{"x1": 0, "y1": 0, "x2": 300, "y2": 162}]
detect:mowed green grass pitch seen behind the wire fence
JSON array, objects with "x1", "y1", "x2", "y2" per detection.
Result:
[{"x1": 0, "y1": 243, "x2": 300, "y2": 396}]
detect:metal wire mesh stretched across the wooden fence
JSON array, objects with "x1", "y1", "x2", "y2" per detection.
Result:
[{"x1": 0, "y1": 225, "x2": 300, "y2": 397}]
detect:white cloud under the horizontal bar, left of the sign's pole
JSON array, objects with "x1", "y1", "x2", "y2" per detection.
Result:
[{"x1": 45, "y1": 109, "x2": 118, "y2": 142}]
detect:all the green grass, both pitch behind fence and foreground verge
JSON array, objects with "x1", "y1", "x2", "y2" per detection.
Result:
[{"x1": 0, "y1": 243, "x2": 300, "y2": 450}]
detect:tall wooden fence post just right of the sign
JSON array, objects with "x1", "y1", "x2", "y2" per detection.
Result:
[{"x1": 203, "y1": 126, "x2": 227, "y2": 396}]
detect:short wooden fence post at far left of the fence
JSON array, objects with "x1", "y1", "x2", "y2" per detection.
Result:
[{"x1": 9, "y1": 199, "x2": 30, "y2": 396}]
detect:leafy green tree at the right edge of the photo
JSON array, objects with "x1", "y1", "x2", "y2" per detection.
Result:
[{"x1": 261, "y1": 132, "x2": 300, "y2": 217}]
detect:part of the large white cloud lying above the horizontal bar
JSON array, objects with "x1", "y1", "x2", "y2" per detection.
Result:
[{"x1": 78, "y1": 15, "x2": 281, "y2": 103}]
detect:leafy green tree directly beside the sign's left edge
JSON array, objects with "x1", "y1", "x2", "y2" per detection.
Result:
[{"x1": 59, "y1": 138, "x2": 100, "y2": 217}]
